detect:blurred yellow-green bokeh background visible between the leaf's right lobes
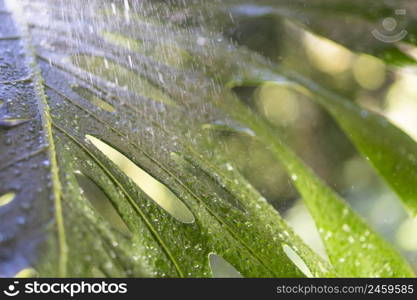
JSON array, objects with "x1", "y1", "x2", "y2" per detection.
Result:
[{"x1": 216, "y1": 4, "x2": 417, "y2": 270}]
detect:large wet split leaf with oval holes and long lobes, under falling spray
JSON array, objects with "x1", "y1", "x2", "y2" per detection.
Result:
[{"x1": 0, "y1": 0, "x2": 417, "y2": 277}]
